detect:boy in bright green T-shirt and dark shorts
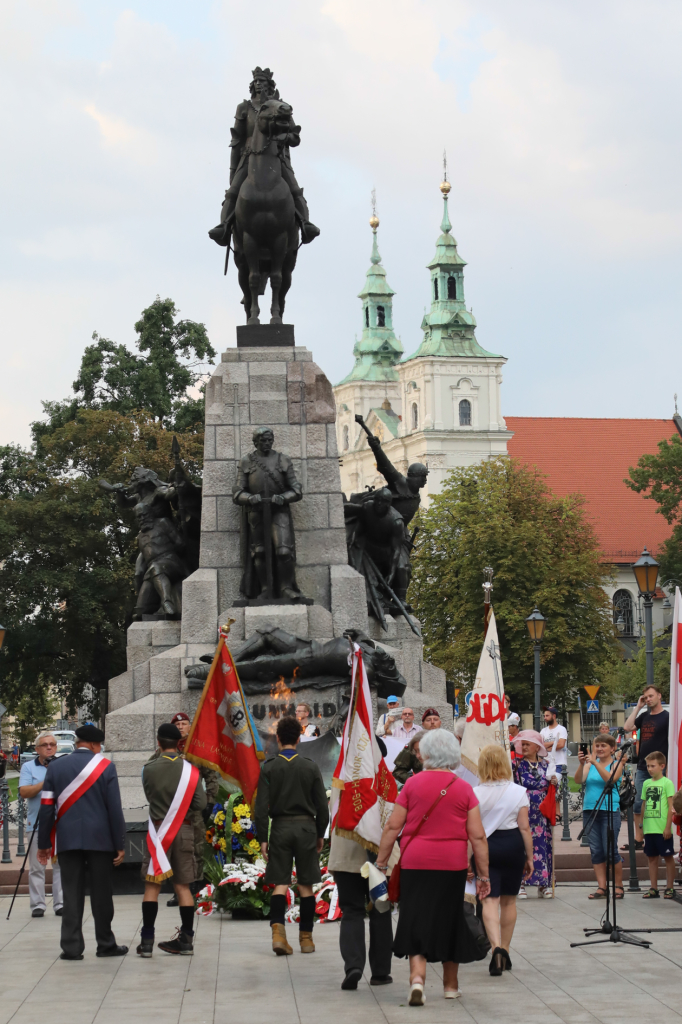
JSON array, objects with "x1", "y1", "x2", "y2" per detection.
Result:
[{"x1": 642, "y1": 751, "x2": 675, "y2": 899}]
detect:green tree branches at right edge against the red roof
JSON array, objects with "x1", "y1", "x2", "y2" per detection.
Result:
[{"x1": 625, "y1": 434, "x2": 682, "y2": 585}]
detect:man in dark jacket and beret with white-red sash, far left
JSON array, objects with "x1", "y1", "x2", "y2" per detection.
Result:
[{"x1": 38, "y1": 725, "x2": 128, "y2": 959}]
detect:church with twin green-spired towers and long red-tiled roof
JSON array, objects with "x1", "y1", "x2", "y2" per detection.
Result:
[{"x1": 334, "y1": 181, "x2": 682, "y2": 652}]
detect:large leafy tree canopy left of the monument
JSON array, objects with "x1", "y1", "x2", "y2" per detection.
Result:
[{"x1": 0, "y1": 299, "x2": 213, "y2": 722}]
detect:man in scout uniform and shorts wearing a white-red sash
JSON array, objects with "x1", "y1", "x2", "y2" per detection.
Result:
[{"x1": 137, "y1": 723, "x2": 206, "y2": 957}]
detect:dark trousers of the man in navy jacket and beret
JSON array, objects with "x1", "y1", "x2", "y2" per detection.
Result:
[{"x1": 57, "y1": 850, "x2": 116, "y2": 956}]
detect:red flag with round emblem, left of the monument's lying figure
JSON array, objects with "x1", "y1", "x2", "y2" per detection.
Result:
[{"x1": 184, "y1": 624, "x2": 265, "y2": 806}]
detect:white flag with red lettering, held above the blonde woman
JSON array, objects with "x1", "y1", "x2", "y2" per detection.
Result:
[{"x1": 462, "y1": 605, "x2": 509, "y2": 778}]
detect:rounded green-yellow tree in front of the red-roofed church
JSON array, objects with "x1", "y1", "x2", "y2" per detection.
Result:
[{"x1": 410, "y1": 459, "x2": 617, "y2": 707}]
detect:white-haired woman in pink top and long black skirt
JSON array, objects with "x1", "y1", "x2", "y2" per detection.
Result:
[{"x1": 377, "y1": 729, "x2": 491, "y2": 1007}]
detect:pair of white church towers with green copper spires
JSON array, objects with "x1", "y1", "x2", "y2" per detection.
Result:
[{"x1": 334, "y1": 181, "x2": 511, "y2": 501}]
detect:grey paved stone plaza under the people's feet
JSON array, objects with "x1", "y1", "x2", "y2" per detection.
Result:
[{"x1": 0, "y1": 886, "x2": 682, "y2": 1024}]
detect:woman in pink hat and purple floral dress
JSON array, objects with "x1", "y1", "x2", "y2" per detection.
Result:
[{"x1": 513, "y1": 729, "x2": 557, "y2": 899}]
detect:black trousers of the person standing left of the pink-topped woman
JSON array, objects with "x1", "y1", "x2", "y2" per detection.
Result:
[{"x1": 334, "y1": 871, "x2": 393, "y2": 978}]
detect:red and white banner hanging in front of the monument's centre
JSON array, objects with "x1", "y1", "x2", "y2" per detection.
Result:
[{"x1": 331, "y1": 644, "x2": 397, "y2": 853}]
